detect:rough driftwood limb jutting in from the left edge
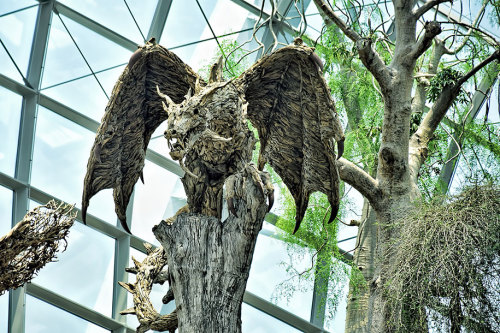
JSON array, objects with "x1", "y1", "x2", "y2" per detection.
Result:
[{"x1": 0, "y1": 200, "x2": 76, "y2": 295}]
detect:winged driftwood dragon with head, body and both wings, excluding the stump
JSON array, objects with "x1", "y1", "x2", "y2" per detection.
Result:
[{"x1": 82, "y1": 40, "x2": 344, "y2": 232}]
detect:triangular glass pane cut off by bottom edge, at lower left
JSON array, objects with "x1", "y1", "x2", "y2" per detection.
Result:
[{"x1": 25, "y1": 295, "x2": 109, "y2": 333}]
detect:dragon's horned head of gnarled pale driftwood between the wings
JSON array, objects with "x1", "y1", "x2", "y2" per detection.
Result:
[{"x1": 158, "y1": 81, "x2": 255, "y2": 177}]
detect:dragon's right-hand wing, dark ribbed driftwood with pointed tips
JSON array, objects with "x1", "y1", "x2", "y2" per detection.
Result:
[{"x1": 235, "y1": 42, "x2": 344, "y2": 233}]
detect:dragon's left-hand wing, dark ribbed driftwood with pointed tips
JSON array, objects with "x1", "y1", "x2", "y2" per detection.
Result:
[{"x1": 82, "y1": 40, "x2": 199, "y2": 233}]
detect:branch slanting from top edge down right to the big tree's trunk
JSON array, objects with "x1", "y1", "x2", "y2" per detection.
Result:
[{"x1": 314, "y1": 0, "x2": 390, "y2": 91}]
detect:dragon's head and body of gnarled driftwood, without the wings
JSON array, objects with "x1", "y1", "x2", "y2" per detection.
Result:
[{"x1": 165, "y1": 82, "x2": 255, "y2": 218}]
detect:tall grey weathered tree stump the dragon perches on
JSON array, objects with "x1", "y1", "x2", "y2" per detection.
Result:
[{"x1": 154, "y1": 164, "x2": 270, "y2": 333}]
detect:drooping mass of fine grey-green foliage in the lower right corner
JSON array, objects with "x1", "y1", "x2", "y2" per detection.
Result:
[{"x1": 385, "y1": 185, "x2": 500, "y2": 332}]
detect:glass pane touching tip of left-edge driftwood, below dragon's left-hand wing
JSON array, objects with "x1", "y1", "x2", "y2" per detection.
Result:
[{"x1": 31, "y1": 222, "x2": 115, "y2": 314}]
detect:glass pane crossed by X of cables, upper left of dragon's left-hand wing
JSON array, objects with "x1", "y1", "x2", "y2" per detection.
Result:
[{"x1": 42, "y1": 16, "x2": 131, "y2": 120}]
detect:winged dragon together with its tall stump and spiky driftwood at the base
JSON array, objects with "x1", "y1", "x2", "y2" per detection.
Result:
[{"x1": 82, "y1": 40, "x2": 344, "y2": 332}]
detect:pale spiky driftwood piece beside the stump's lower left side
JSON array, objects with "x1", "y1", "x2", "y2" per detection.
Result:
[{"x1": 118, "y1": 243, "x2": 177, "y2": 333}]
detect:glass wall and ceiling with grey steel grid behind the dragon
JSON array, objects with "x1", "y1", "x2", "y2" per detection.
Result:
[{"x1": 0, "y1": 0, "x2": 498, "y2": 333}]
